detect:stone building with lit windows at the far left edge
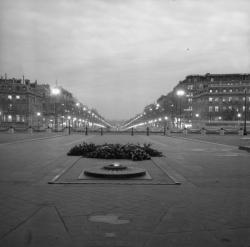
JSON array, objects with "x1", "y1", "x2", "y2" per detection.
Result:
[{"x1": 0, "y1": 78, "x2": 43, "y2": 127}]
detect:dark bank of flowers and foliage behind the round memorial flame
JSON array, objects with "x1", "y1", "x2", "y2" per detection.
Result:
[{"x1": 68, "y1": 142, "x2": 162, "y2": 161}]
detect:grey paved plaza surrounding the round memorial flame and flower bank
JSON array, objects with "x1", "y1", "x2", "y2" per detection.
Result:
[{"x1": 0, "y1": 134, "x2": 250, "y2": 247}]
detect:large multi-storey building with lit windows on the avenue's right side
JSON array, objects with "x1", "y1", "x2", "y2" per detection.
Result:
[{"x1": 174, "y1": 74, "x2": 250, "y2": 122}]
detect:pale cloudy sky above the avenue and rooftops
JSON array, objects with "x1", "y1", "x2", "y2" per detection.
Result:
[{"x1": 0, "y1": 0, "x2": 250, "y2": 119}]
